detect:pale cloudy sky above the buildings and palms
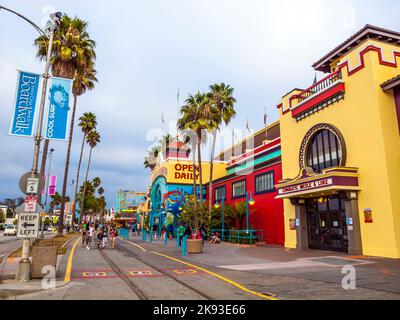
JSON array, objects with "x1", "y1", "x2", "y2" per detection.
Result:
[{"x1": 0, "y1": 0, "x2": 400, "y2": 208}]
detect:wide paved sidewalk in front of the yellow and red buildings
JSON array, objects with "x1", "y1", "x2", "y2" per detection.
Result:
[{"x1": 125, "y1": 232, "x2": 400, "y2": 298}]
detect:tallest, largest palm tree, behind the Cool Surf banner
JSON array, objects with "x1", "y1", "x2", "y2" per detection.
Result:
[{"x1": 34, "y1": 15, "x2": 97, "y2": 235}]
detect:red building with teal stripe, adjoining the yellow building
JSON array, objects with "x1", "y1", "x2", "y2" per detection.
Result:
[{"x1": 207, "y1": 122, "x2": 285, "y2": 245}]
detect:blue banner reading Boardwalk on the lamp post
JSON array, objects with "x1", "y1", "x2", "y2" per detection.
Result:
[{"x1": 10, "y1": 71, "x2": 40, "y2": 137}]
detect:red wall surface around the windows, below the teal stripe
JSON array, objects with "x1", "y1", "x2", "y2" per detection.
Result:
[{"x1": 207, "y1": 163, "x2": 285, "y2": 245}]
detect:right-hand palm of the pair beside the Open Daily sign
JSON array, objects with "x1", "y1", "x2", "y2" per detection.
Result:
[{"x1": 207, "y1": 83, "x2": 236, "y2": 219}]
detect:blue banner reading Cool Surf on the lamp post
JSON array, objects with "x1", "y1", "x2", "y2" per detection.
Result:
[{"x1": 45, "y1": 78, "x2": 72, "y2": 140}]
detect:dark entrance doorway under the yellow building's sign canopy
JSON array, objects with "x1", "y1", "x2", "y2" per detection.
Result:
[{"x1": 307, "y1": 197, "x2": 349, "y2": 253}]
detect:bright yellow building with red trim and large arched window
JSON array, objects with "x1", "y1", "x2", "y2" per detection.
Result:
[{"x1": 277, "y1": 25, "x2": 400, "y2": 258}]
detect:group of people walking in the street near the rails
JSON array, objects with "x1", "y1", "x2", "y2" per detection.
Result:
[{"x1": 82, "y1": 223, "x2": 118, "y2": 250}]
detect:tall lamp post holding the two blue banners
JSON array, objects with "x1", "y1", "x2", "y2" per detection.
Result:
[{"x1": 0, "y1": 6, "x2": 62, "y2": 281}]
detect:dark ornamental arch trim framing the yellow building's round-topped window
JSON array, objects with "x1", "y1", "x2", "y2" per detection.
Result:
[{"x1": 299, "y1": 123, "x2": 347, "y2": 169}]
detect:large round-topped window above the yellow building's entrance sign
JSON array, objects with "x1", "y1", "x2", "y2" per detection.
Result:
[{"x1": 307, "y1": 129, "x2": 342, "y2": 173}]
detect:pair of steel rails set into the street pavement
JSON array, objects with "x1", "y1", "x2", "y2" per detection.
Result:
[{"x1": 99, "y1": 244, "x2": 213, "y2": 300}]
